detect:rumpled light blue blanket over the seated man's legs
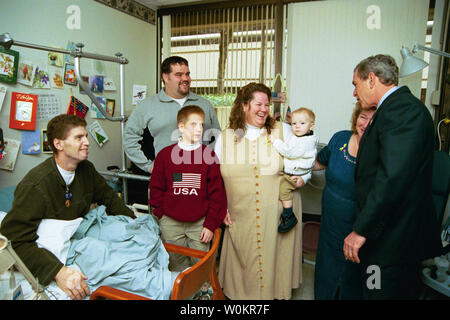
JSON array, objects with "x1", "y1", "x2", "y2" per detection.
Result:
[{"x1": 66, "y1": 206, "x2": 178, "y2": 299}]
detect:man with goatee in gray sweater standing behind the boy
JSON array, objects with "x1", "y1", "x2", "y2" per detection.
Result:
[{"x1": 123, "y1": 56, "x2": 220, "y2": 173}]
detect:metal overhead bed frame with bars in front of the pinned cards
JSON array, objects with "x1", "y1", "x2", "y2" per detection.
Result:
[{"x1": 0, "y1": 33, "x2": 149, "y2": 204}]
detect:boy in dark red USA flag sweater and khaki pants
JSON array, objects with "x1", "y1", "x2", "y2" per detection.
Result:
[{"x1": 149, "y1": 105, "x2": 227, "y2": 271}]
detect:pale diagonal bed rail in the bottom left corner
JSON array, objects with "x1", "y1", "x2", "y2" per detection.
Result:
[{"x1": 0, "y1": 235, "x2": 49, "y2": 300}]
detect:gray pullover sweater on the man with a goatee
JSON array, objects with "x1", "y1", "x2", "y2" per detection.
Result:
[{"x1": 122, "y1": 90, "x2": 220, "y2": 172}]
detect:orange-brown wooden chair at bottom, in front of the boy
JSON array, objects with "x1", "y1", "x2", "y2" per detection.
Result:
[{"x1": 90, "y1": 228, "x2": 225, "y2": 300}]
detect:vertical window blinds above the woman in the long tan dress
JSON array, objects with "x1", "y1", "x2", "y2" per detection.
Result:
[{"x1": 165, "y1": 4, "x2": 275, "y2": 96}]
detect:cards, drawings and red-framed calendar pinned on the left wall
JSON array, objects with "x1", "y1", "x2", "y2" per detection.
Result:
[{"x1": 0, "y1": 40, "x2": 123, "y2": 171}]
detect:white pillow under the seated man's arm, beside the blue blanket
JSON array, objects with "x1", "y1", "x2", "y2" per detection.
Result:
[{"x1": 36, "y1": 218, "x2": 83, "y2": 264}]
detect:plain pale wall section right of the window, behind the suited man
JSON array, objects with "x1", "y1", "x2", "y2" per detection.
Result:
[{"x1": 286, "y1": 0, "x2": 428, "y2": 143}]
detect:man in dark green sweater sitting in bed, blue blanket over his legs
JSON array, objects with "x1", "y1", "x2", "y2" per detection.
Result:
[{"x1": 0, "y1": 115, "x2": 177, "y2": 299}]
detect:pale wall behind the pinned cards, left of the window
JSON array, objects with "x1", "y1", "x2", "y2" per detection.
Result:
[{"x1": 0, "y1": 0, "x2": 156, "y2": 188}]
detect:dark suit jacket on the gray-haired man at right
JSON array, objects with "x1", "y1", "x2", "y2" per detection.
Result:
[{"x1": 353, "y1": 86, "x2": 442, "y2": 266}]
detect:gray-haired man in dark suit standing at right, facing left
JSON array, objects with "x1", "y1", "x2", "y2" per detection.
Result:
[{"x1": 343, "y1": 55, "x2": 442, "y2": 299}]
